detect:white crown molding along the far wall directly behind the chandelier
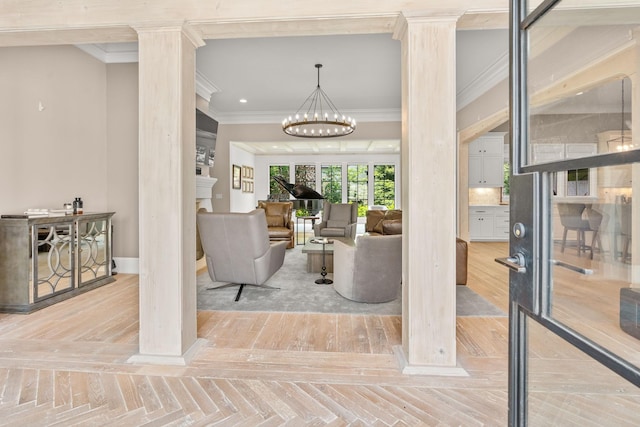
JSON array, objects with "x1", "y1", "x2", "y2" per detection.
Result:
[{"x1": 209, "y1": 108, "x2": 401, "y2": 125}]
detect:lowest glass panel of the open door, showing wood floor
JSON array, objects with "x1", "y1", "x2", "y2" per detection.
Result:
[{"x1": 527, "y1": 319, "x2": 640, "y2": 427}]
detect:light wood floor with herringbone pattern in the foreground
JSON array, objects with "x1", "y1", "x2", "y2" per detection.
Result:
[{"x1": 0, "y1": 243, "x2": 640, "y2": 426}]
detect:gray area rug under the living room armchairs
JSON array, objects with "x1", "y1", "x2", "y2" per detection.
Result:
[{"x1": 197, "y1": 246, "x2": 505, "y2": 317}]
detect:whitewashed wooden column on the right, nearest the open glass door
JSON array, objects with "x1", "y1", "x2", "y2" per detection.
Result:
[{"x1": 394, "y1": 13, "x2": 466, "y2": 375}]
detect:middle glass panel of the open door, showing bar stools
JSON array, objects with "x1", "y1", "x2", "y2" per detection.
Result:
[{"x1": 547, "y1": 163, "x2": 640, "y2": 372}]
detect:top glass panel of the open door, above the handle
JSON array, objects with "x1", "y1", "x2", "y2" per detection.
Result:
[{"x1": 524, "y1": 5, "x2": 640, "y2": 169}]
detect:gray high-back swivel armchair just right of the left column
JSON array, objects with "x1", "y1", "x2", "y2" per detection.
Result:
[{"x1": 197, "y1": 209, "x2": 288, "y2": 301}]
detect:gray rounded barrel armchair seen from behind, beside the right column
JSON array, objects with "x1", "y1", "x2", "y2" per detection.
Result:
[{"x1": 333, "y1": 234, "x2": 402, "y2": 303}]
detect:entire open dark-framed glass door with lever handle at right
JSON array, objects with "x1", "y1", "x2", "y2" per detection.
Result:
[{"x1": 504, "y1": 0, "x2": 640, "y2": 426}]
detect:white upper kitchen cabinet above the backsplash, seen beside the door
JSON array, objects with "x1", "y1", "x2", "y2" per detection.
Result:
[{"x1": 469, "y1": 133, "x2": 504, "y2": 187}]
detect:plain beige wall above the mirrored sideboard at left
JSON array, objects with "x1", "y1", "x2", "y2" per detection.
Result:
[{"x1": 0, "y1": 46, "x2": 109, "y2": 214}]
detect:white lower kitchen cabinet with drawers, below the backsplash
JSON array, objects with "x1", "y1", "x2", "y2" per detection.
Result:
[{"x1": 469, "y1": 205, "x2": 510, "y2": 242}]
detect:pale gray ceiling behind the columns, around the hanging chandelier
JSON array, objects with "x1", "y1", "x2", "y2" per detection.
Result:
[{"x1": 78, "y1": 30, "x2": 508, "y2": 154}]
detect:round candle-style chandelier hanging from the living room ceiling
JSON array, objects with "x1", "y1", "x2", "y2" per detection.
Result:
[{"x1": 282, "y1": 64, "x2": 356, "y2": 138}]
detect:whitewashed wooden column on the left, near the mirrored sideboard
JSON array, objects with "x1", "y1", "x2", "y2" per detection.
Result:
[{"x1": 130, "y1": 25, "x2": 201, "y2": 365}]
